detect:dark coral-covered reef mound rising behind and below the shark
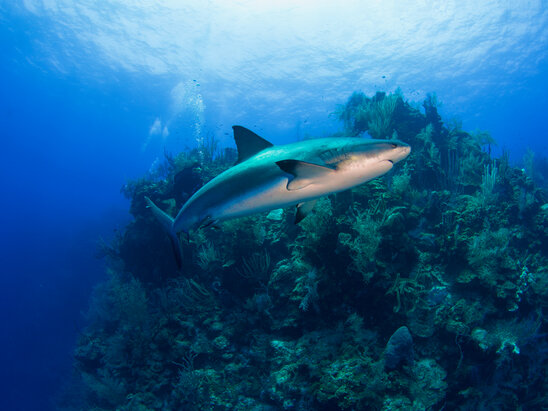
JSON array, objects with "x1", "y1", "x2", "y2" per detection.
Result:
[{"x1": 65, "y1": 92, "x2": 548, "y2": 410}]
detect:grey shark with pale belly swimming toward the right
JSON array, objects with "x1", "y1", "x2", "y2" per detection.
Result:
[{"x1": 146, "y1": 126, "x2": 411, "y2": 265}]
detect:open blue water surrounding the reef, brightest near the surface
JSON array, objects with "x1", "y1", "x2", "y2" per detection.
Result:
[{"x1": 0, "y1": 0, "x2": 548, "y2": 410}]
